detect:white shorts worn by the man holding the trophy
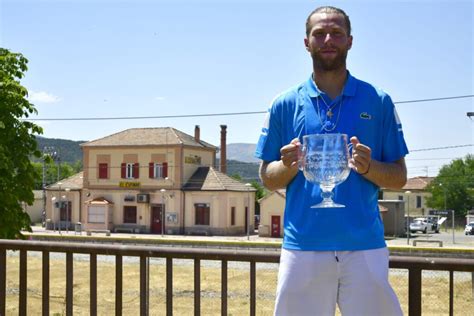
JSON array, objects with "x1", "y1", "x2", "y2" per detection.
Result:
[{"x1": 275, "y1": 248, "x2": 403, "y2": 316}]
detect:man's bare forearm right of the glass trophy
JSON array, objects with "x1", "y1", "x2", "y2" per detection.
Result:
[{"x1": 363, "y1": 158, "x2": 407, "y2": 189}]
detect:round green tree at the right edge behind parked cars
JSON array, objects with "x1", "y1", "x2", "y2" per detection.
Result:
[{"x1": 427, "y1": 155, "x2": 474, "y2": 216}]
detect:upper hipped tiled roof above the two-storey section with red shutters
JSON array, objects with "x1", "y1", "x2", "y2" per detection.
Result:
[{"x1": 81, "y1": 127, "x2": 217, "y2": 149}]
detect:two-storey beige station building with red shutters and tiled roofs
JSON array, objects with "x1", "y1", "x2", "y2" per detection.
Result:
[{"x1": 47, "y1": 125, "x2": 256, "y2": 235}]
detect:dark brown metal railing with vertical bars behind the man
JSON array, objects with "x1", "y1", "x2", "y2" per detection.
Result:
[{"x1": 0, "y1": 240, "x2": 474, "y2": 315}]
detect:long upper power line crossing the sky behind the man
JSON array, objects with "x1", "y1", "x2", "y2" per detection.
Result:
[{"x1": 24, "y1": 94, "x2": 474, "y2": 121}]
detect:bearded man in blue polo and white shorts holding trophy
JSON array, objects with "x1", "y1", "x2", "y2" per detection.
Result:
[{"x1": 256, "y1": 7, "x2": 408, "y2": 316}]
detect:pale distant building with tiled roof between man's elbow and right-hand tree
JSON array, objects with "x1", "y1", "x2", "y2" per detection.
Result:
[{"x1": 379, "y1": 177, "x2": 434, "y2": 217}]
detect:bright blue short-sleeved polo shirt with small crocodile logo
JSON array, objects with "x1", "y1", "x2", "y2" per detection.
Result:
[{"x1": 255, "y1": 72, "x2": 408, "y2": 251}]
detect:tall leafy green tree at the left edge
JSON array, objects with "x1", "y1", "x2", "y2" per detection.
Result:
[{"x1": 0, "y1": 48, "x2": 42, "y2": 239}]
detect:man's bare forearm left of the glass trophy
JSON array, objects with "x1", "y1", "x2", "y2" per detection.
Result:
[{"x1": 260, "y1": 160, "x2": 298, "y2": 191}]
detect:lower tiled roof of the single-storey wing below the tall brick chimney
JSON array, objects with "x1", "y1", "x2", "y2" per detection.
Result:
[{"x1": 183, "y1": 167, "x2": 256, "y2": 192}]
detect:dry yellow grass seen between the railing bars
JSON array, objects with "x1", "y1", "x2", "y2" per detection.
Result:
[{"x1": 7, "y1": 255, "x2": 473, "y2": 315}]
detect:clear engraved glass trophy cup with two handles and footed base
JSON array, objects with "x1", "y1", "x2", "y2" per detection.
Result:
[{"x1": 298, "y1": 134, "x2": 350, "y2": 208}]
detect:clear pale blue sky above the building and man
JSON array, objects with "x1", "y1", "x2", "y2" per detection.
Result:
[{"x1": 0, "y1": 0, "x2": 474, "y2": 176}]
